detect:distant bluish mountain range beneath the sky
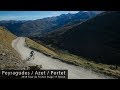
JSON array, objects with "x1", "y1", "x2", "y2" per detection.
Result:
[{"x1": 0, "y1": 11, "x2": 99, "y2": 36}]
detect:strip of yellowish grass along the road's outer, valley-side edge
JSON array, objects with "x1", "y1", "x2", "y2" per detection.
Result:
[{"x1": 26, "y1": 38, "x2": 120, "y2": 78}]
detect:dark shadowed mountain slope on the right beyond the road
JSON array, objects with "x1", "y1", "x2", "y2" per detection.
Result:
[{"x1": 37, "y1": 12, "x2": 120, "y2": 65}]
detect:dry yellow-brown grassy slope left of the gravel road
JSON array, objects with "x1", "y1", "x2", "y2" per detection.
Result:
[{"x1": 0, "y1": 27, "x2": 26, "y2": 70}]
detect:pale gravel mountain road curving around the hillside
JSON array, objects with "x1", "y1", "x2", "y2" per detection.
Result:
[{"x1": 12, "y1": 37, "x2": 110, "y2": 79}]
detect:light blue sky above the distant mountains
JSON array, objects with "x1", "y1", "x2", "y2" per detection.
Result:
[{"x1": 0, "y1": 11, "x2": 78, "y2": 20}]
